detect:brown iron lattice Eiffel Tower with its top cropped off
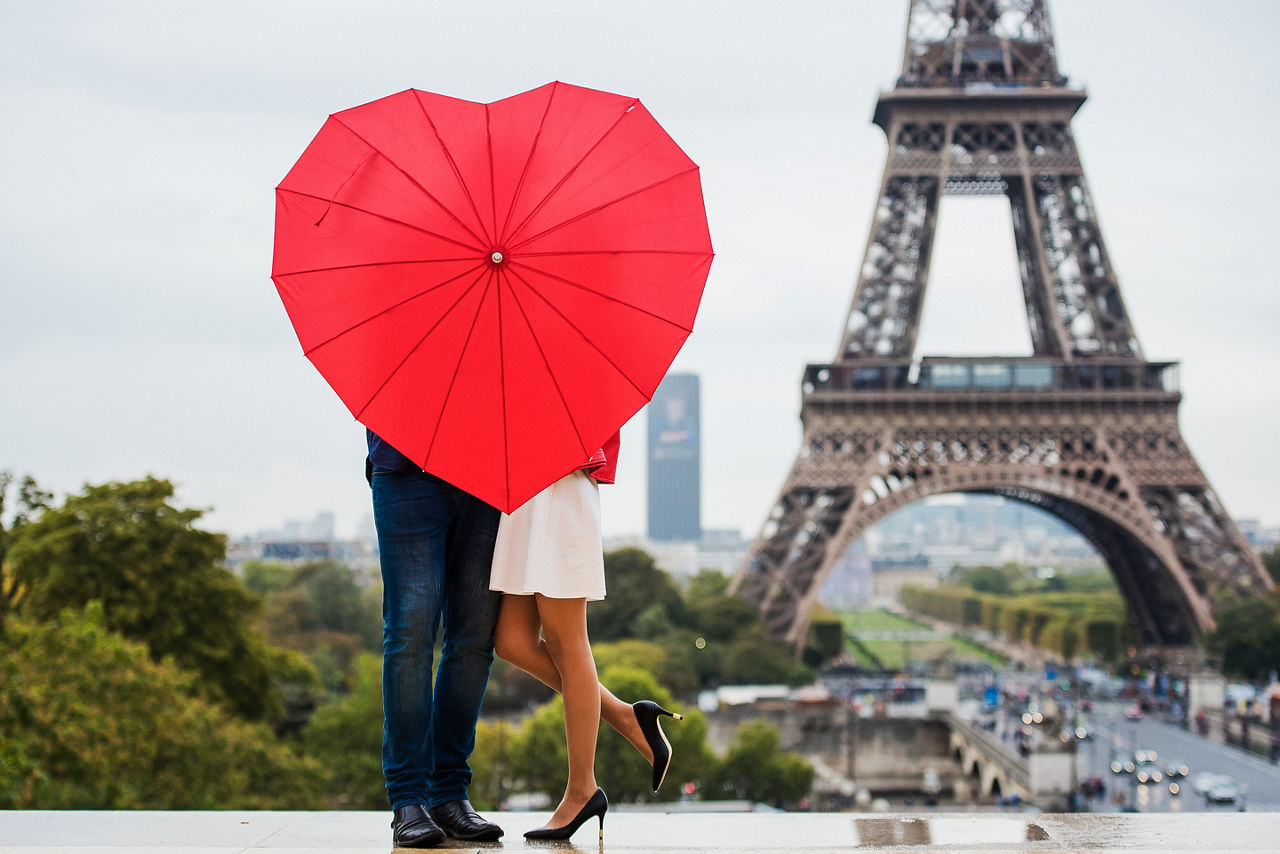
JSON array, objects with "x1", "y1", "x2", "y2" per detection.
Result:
[{"x1": 733, "y1": 0, "x2": 1271, "y2": 649}]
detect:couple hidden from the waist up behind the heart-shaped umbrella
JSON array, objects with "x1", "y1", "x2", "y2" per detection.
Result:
[{"x1": 366, "y1": 431, "x2": 680, "y2": 848}]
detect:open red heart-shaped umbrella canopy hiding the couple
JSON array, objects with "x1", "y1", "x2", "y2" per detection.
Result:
[{"x1": 271, "y1": 83, "x2": 712, "y2": 511}]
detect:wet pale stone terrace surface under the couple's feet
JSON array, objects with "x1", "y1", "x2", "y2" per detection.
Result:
[{"x1": 0, "y1": 810, "x2": 1280, "y2": 854}]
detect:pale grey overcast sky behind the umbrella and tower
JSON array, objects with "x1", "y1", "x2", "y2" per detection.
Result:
[{"x1": 0, "y1": 0, "x2": 1280, "y2": 535}]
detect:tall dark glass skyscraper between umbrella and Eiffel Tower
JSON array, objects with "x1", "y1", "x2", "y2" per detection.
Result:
[{"x1": 649, "y1": 374, "x2": 703, "y2": 540}]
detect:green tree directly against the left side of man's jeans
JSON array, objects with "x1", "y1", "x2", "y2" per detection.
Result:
[{"x1": 302, "y1": 654, "x2": 387, "y2": 809}]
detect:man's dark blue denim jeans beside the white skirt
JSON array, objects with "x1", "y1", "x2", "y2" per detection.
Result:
[{"x1": 371, "y1": 469, "x2": 502, "y2": 809}]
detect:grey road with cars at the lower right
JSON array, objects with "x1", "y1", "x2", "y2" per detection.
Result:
[{"x1": 1078, "y1": 703, "x2": 1280, "y2": 812}]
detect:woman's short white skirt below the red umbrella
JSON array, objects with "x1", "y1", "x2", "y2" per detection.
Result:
[{"x1": 489, "y1": 471, "x2": 604, "y2": 600}]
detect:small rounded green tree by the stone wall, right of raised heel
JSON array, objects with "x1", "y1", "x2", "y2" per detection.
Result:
[{"x1": 703, "y1": 721, "x2": 814, "y2": 805}]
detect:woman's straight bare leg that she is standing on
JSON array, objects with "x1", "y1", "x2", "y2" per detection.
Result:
[{"x1": 534, "y1": 594, "x2": 600, "y2": 827}]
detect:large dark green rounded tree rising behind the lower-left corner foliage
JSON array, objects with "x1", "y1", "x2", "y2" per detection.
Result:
[{"x1": 8, "y1": 478, "x2": 282, "y2": 720}]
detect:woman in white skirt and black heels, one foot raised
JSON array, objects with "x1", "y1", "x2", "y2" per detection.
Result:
[{"x1": 489, "y1": 434, "x2": 681, "y2": 840}]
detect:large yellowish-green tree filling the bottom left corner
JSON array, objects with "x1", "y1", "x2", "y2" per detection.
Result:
[{"x1": 0, "y1": 602, "x2": 320, "y2": 809}]
